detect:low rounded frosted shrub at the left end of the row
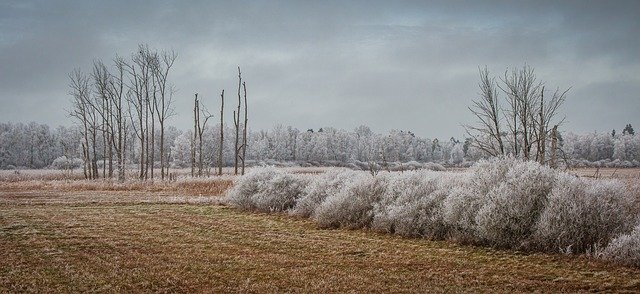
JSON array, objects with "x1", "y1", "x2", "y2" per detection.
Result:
[{"x1": 226, "y1": 167, "x2": 307, "y2": 212}]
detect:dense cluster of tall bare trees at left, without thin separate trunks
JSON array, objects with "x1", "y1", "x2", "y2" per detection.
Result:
[{"x1": 69, "y1": 45, "x2": 177, "y2": 181}]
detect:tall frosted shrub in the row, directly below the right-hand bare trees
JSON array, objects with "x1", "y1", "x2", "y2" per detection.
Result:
[{"x1": 475, "y1": 161, "x2": 557, "y2": 248}]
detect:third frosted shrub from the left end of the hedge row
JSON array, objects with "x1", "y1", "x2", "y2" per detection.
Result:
[{"x1": 314, "y1": 173, "x2": 388, "y2": 229}]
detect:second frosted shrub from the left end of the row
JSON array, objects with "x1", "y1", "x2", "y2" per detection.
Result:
[{"x1": 291, "y1": 169, "x2": 362, "y2": 217}]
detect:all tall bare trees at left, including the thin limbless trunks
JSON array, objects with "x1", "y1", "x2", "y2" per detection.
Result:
[{"x1": 69, "y1": 45, "x2": 248, "y2": 181}]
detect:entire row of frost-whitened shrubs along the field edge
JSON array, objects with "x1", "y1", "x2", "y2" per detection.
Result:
[{"x1": 226, "y1": 158, "x2": 640, "y2": 266}]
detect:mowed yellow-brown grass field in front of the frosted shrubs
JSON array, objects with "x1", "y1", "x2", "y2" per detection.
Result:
[{"x1": 0, "y1": 170, "x2": 640, "y2": 293}]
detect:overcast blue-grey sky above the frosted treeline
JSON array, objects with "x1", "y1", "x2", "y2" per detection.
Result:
[{"x1": 0, "y1": 0, "x2": 640, "y2": 138}]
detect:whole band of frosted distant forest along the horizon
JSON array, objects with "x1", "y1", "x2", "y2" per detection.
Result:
[{"x1": 0, "y1": 122, "x2": 640, "y2": 169}]
